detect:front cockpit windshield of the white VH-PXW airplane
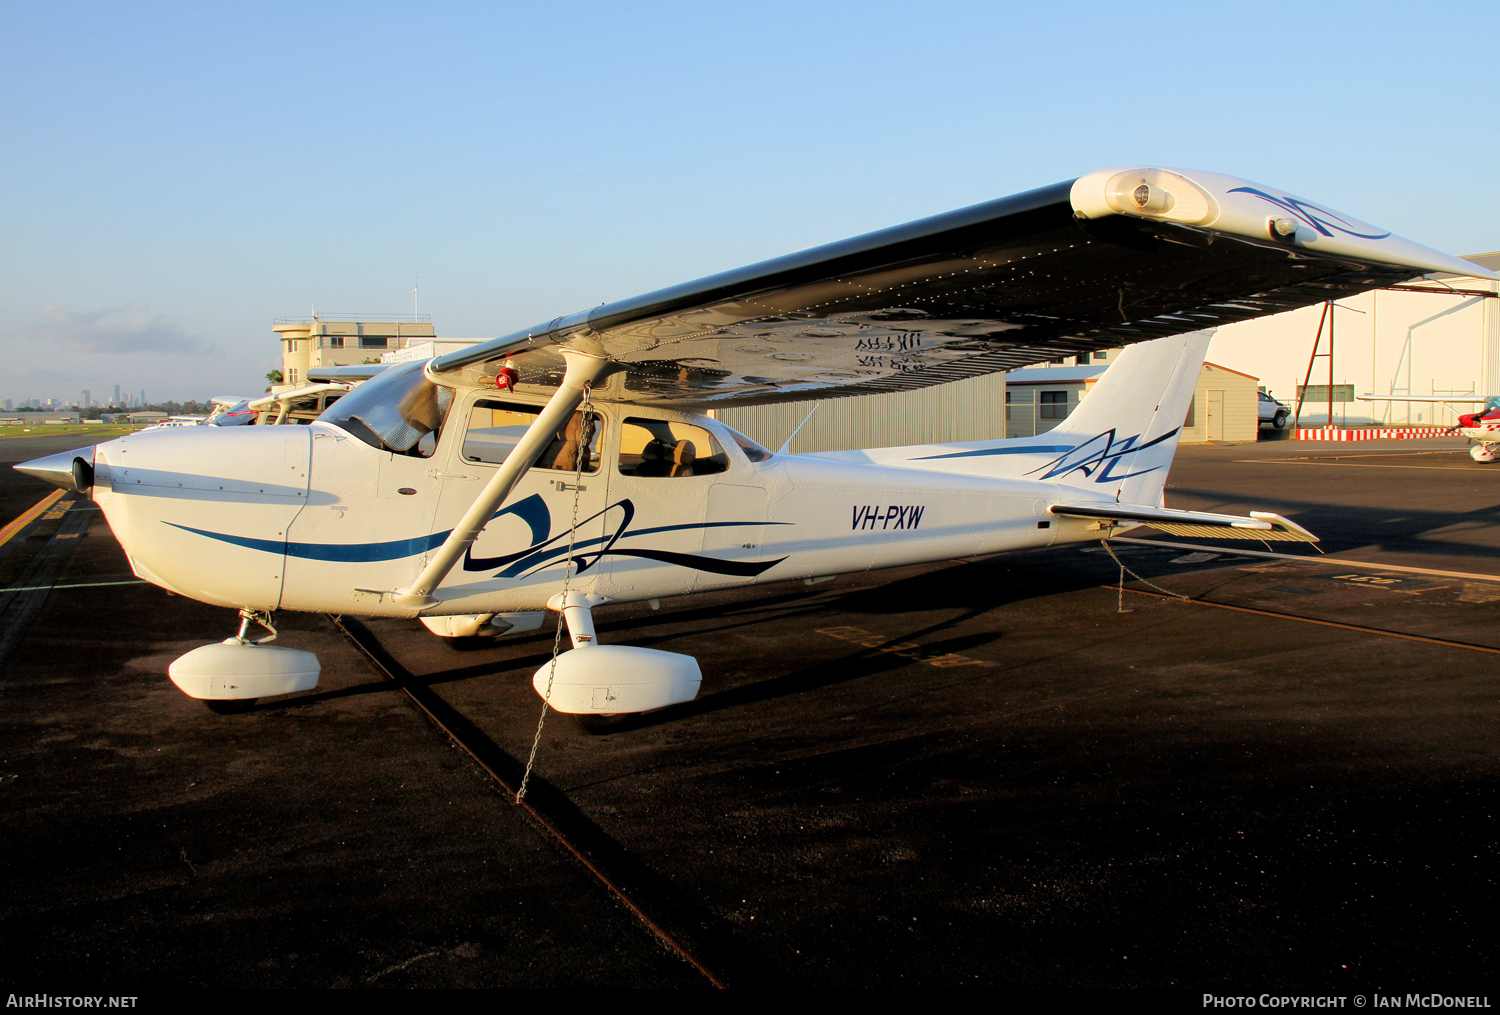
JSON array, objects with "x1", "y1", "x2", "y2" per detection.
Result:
[{"x1": 318, "y1": 360, "x2": 453, "y2": 457}]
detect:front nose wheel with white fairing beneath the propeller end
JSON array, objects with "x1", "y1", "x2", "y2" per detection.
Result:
[{"x1": 167, "y1": 609, "x2": 323, "y2": 712}]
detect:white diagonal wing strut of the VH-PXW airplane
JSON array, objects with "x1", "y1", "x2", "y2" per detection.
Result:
[{"x1": 392, "y1": 349, "x2": 618, "y2": 610}]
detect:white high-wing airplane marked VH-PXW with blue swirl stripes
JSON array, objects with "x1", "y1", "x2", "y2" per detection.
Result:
[{"x1": 17, "y1": 168, "x2": 1500, "y2": 715}]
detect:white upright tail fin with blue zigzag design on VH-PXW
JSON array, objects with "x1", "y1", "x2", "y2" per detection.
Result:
[{"x1": 1031, "y1": 331, "x2": 1214, "y2": 504}]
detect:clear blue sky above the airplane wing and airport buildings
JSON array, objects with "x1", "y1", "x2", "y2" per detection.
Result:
[{"x1": 0, "y1": 0, "x2": 1500, "y2": 400}]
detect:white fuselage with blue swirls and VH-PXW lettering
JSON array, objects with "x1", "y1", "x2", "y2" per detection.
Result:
[{"x1": 93, "y1": 390, "x2": 1100, "y2": 618}]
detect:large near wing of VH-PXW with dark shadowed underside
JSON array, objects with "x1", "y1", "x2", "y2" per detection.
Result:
[{"x1": 429, "y1": 168, "x2": 1500, "y2": 408}]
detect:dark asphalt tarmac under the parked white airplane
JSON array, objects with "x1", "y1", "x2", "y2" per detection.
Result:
[{"x1": 0, "y1": 438, "x2": 1500, "y2": 994}]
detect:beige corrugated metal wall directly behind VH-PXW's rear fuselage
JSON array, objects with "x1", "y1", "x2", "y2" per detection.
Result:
[{"x1": 719, "y1": 373, "x2": 1005, "y2": 454}]
